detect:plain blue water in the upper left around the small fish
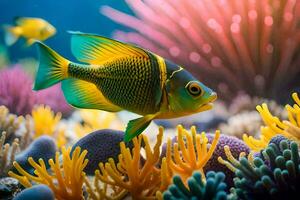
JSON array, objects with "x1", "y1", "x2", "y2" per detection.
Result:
[{"x1": 0, "y1": 0, "x2": 132, "y2": 62}]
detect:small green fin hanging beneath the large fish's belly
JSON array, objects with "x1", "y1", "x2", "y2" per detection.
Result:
[{"x1": 124, "y1": 114, "x2": 157, "y2": 142}]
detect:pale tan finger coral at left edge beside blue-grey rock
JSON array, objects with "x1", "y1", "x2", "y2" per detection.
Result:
[{"x1": 0, "y1": 132, "x2": 19, "y2": 177}]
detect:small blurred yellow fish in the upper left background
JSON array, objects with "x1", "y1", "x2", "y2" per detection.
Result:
[{"x1": 4, "y1": 17, "x2": 56, "y2": 46}]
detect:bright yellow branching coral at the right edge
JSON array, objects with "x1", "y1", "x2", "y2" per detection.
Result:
[{"x1": 243, "y1": 93, "x2": 300, "y2": 152}]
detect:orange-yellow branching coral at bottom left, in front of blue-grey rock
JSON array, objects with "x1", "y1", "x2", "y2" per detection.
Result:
[{"x1": 8, "y1": 147, "x2": 88, "y2": 200}]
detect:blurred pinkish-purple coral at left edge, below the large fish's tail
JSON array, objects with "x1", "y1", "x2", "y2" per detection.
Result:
[{"x1": 0, "y1": 65, "x2": 72, "y2": 115}]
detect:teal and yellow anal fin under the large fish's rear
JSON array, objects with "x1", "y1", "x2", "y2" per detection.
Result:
[{"x1": 62, "y1": 78, "x2": 122, "y2": 112}]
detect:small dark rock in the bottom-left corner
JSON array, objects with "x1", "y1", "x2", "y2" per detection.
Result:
[{"x1": 0, "y1": 177, "x2": 20, "y2": 200}]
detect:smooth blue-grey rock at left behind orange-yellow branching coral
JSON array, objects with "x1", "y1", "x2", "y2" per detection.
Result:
[{"x1": 13, "y1": 135, "x2": 57, "y2": 173}]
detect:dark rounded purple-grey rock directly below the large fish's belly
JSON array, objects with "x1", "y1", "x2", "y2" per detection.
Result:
[{"x1": 71, "y1": 129, "x2": 133, "y2": 175}]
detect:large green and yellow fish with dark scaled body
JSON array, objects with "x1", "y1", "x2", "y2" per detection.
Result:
[{"x1": 34, "y1": 32, "x2": 217, "y2": 141}]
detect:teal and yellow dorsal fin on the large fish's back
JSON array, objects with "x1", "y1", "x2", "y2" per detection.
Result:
[{"x1": 70, "y1": 32, "x2": 149, "y2": 65}]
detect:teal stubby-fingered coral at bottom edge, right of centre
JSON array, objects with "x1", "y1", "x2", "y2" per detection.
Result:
[{"x1": 163, "y1": 171, "x2": 227, "y2": 200}]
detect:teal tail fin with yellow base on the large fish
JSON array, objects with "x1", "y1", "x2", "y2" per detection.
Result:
[{"x1": 33, "y1": 42, "x2": 70, "y2": 90}]
